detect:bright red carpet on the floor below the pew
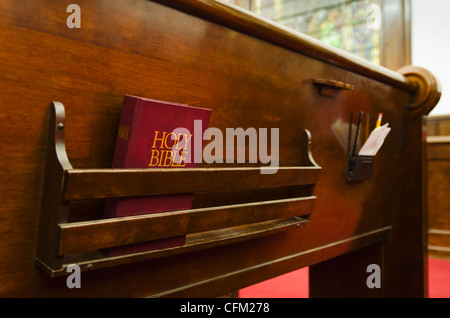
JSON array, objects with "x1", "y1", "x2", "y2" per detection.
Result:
[{"x1": 239, "y1": 258, "x2": 450, "y2": 298}]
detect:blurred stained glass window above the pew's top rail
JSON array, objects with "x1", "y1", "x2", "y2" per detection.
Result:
[{"x1": 229, "y1": 0, "x2": 381, "y2": 64}]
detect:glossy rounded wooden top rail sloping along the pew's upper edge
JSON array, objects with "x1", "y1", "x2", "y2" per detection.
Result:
[{"x1": 156, "y1": 0, "x2": 416, "y2": 92}]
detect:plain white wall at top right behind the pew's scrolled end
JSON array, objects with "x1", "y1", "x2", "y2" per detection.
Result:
[{"x1": 412, "y1": 0, "x2": 450, "y2": 116}]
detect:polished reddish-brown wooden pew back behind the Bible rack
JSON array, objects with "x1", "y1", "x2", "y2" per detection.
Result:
[{"x1": 0, "y1": 0, "x2": 440, "y2": 297}]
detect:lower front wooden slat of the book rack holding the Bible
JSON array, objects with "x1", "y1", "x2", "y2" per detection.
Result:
[{"x1": 59, "y1": 196, "x2": 316, "y2": 255}]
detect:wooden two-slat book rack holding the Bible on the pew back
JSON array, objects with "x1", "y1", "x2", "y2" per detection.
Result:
[{"x1": 36, "y1": 102, "x2": 321, "y2": 277}]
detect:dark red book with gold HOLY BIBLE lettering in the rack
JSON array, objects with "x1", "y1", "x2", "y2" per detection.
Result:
[{"x1": 104, "y1": 95, "x2": 211, "y2": 256}]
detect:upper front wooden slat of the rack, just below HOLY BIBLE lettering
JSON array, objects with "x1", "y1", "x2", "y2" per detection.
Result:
[{"x1": 63, "y1": 167, "x2": 321, "y2": 201}]
